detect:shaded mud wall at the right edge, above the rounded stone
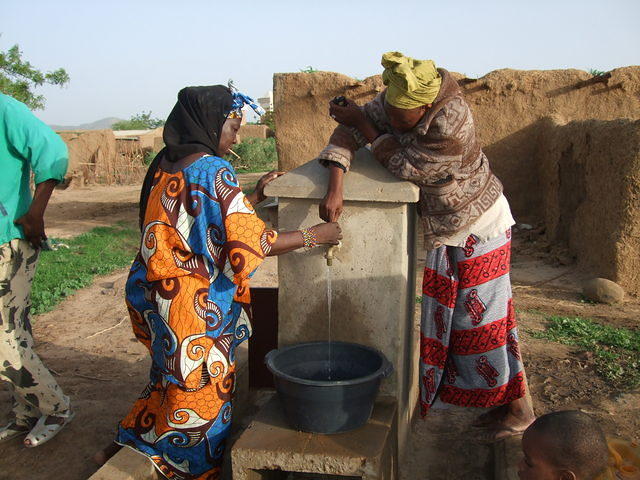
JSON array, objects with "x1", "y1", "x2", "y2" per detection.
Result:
[{"x1": 535, "y1": 116, "x2": 640, "y2": 295}]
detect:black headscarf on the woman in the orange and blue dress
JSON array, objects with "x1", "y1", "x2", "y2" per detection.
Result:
[{"x1": 140, "y1": 85, "x2": 233, "y2": 229}]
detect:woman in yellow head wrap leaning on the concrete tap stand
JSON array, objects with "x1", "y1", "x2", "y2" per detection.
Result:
[{"x1": 319, "y1": 52, "x2": 535, "y2": 440}]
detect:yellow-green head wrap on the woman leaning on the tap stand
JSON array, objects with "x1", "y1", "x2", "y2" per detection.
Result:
[{"x1": 382, "y1": 52, "x2": 442, "y2": 109}]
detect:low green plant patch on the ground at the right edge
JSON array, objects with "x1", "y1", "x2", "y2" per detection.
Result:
[{"x1": 532, "y1": 316, "x2": 640, "y2": 390}]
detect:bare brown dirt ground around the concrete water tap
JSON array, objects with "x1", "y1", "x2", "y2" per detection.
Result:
[{"x1": 0, "y1": 185, "x2": 640, "y2": 480}]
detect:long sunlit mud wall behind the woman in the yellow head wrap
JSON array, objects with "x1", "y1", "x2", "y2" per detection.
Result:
[{"x1": 273, "y1": 67, "x2": 640, "y2": 221}]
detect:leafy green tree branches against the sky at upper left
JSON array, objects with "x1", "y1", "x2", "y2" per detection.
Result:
[{"x1": 0, "y1": 45, "x2": 69, "y2": 110}]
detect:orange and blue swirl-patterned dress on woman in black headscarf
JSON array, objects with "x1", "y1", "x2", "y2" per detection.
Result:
[{"x1": 116, "y1": 155, "x2": 277, "y2": 480}]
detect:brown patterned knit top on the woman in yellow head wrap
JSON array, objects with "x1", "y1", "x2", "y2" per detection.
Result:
[{"x1": 318, "y1": 69, "x2": 502, "y2": 249}]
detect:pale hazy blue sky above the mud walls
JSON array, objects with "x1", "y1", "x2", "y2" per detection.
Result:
[{"x1": 0, "y1": 0, "x2": 640, "y2": 125}]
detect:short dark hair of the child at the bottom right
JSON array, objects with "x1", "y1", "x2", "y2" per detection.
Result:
[{"x1": 527, "y1": 410, "x2": 608, "y2": 480}]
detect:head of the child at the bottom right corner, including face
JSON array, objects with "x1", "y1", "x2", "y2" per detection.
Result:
[{"x1": 518, "y1": 411, "x2": 608, "y2": 480}]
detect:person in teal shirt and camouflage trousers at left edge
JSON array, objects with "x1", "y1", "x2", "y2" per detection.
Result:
[{"x1": 0, "y1": 94, "x2": 73, "y2": 447}]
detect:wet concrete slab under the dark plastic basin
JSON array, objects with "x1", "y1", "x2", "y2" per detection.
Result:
[{"x1": 231, "y1": 395, "x2": 398, "y2": 480}]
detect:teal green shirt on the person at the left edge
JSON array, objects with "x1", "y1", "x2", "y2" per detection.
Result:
[{"x1": 0, "y1": 93, "x2": 69, "y2": 244}]
